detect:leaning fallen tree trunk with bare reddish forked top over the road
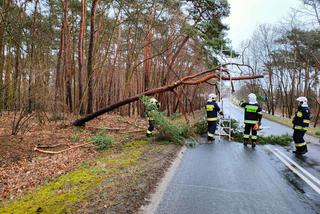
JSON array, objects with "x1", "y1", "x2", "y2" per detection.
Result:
[{"x1": 72, "y1": 63, "x2": 263, "y2": 126}]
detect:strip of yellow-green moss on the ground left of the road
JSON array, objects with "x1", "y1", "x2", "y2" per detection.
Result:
[{"x1": 0, "y1": 140, "x2": 152, "y2": 213}]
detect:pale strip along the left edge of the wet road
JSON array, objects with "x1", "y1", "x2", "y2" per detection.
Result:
[{"x1": 138, "y1": 146, "x2": 187, "y2": 214}]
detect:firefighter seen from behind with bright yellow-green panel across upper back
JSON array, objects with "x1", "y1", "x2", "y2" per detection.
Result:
[{"x1": 240, "y1": 93, "x2": 262, "y2": 148}]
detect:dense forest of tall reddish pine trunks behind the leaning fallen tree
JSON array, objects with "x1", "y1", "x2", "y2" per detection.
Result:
[{"x1": 0, "y1": 0, "x2": 229, "y2": 123}]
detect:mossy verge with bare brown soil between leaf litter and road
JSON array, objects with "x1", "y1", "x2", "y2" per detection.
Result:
[{"x1": 0, "y1": 140, "x2": 179, "y2": 214}]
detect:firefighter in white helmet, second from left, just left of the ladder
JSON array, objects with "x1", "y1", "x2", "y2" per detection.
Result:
[{"x1": 206, "y1": 94, "x2": 223, "y2": 143}]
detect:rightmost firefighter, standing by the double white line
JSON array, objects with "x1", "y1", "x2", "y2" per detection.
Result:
[{"x1": 292, "y1": 97, "x2": 310, "y2": 154}]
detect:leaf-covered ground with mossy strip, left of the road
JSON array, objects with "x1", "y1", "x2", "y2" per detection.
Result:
[{"x1": 0, "y1": 115, "x2": 181, "y2": 213}]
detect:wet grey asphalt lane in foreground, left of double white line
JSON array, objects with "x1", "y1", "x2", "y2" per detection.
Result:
[{"x1": 156, "y1": 142, "x2": 320, "y2": 214}]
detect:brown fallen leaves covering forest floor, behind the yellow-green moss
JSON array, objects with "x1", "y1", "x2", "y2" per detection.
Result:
[{"x1": 0, "y1": 114, "x2": 146, "y2": 200}]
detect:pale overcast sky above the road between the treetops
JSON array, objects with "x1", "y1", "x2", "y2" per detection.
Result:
[{"x1": 225, "y1": 0, "x2": 302, "y2": 49}]
